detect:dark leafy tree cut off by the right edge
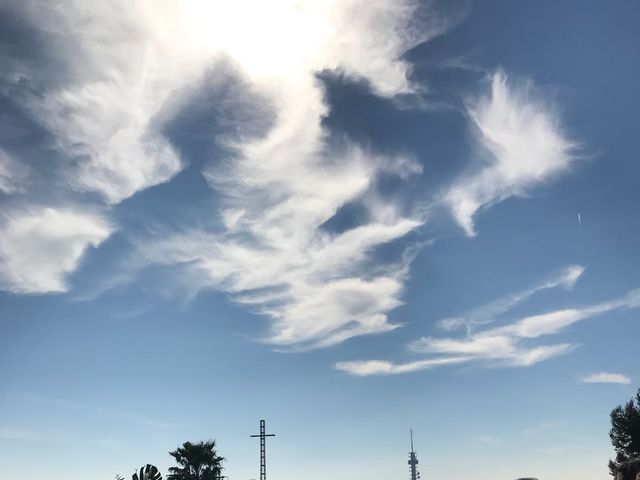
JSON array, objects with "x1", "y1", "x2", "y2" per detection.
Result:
[{"x1": 609, "y1": 389, "x2": 640, "y2": 475}]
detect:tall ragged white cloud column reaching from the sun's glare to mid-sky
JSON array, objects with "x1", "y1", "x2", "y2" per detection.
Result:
[{"x1": 129, "y1": 0, "x2": 450, "y2": 348}]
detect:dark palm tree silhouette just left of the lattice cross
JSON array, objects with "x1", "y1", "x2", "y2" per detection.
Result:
[{"x1": 167, "y1": 440, "x2": 224, "y2": 480}]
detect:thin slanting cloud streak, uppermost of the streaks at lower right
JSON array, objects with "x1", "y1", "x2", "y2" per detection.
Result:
[{"x1": 436, "y1": 265, "x2": 585, "y2": 331}]
